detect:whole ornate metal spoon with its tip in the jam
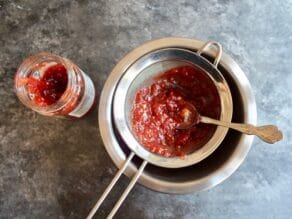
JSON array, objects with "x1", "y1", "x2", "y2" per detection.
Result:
[{"x1": 176, "y1": 102, "x2": 283, "y2": 144}]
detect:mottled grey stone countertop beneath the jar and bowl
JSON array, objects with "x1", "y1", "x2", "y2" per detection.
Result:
[{"x1": 0, "y1": 0, "x2": 292, "y2": 219}]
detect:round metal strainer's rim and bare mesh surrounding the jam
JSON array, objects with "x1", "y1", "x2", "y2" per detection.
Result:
[{"x1": 113, "y1": 45, "x2": 233, "y2": 168}]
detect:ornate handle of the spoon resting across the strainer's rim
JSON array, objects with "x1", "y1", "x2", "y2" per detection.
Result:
[{"x1": 201, "y1": 116, "x2": 283, "y2": 144}]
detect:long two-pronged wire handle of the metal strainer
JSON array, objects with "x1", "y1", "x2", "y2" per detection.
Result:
[{"x1": 86, "y1": 152, "x2": 147, "y2": 219}]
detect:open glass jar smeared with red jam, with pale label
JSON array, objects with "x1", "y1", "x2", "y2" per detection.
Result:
[{"x1": 15, "y1": 53, "x2": 95, "y2": 118}]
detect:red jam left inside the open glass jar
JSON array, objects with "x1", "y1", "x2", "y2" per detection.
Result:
[{"x1": 27, "y1": 64, "x2": 68, "y2": 106}]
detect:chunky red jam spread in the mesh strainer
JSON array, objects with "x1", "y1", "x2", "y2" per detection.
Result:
[{"x1": 132, "y1": 66, "x2": 221, "y2": 157}]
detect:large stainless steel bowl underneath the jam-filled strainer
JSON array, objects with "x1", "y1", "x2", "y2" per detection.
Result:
[{"x1": 99, "y1": 38, "x2": 256, "y2": 193}]
